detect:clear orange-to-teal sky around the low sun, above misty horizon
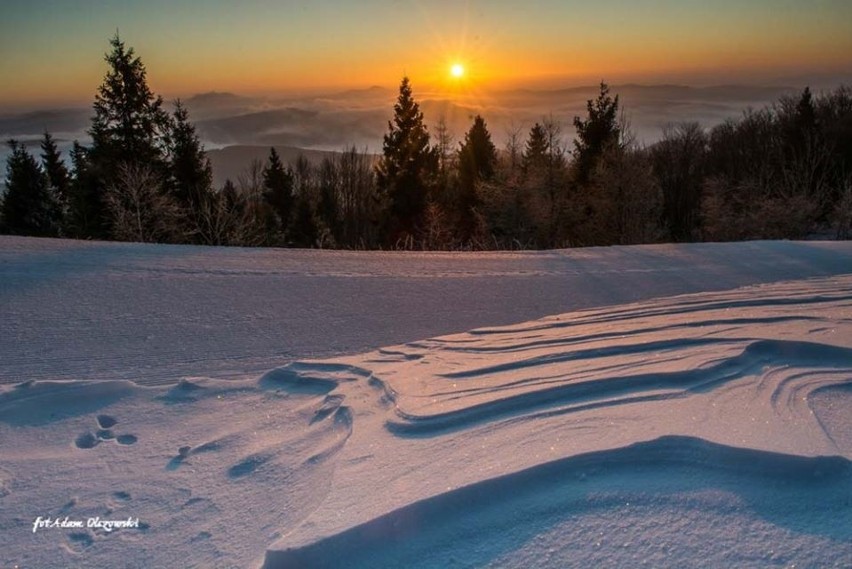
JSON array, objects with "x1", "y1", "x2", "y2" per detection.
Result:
[{"x1": 0, "y1": 0, "x2": 852, "y2": 108}]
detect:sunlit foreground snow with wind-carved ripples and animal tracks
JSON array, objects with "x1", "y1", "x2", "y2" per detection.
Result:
[{"x1": 0, "y1": 270, "x2": 852, "y2": 569}]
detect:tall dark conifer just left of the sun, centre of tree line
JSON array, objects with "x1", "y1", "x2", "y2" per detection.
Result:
[{"x1": 376, "y1": 77, "x2": 437, "y2": 244}]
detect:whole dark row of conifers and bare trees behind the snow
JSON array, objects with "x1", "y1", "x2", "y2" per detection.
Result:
[{"x1": 0, "y1": 35, "x2": 852, "y2": 250}]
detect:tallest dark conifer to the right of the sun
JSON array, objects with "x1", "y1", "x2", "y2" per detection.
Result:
[{"x1": 574, "y1": 82, "x2": 621, "y2": 183}]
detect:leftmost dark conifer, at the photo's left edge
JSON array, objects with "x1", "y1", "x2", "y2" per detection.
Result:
[{"x1": 0, "y1": 140, "x2": 59, "y2": 237}]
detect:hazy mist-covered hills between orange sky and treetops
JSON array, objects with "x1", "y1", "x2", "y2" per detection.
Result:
[{"x1": 0, "y1": 85, "x2": 798, "y2": 189}]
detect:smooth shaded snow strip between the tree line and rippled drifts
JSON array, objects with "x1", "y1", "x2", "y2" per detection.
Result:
[{"x1": 0, "y1": 236, "x2": 852, "y2": 385}]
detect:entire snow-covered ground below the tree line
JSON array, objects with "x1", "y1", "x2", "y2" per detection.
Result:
[{"x1": 0, "y1": 239, "x2": 852, "y2": 568}]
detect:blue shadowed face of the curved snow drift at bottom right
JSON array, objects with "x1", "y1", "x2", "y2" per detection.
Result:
[{"x1": 265, "y1": 436, "x2": 852, "y2": 568}]
